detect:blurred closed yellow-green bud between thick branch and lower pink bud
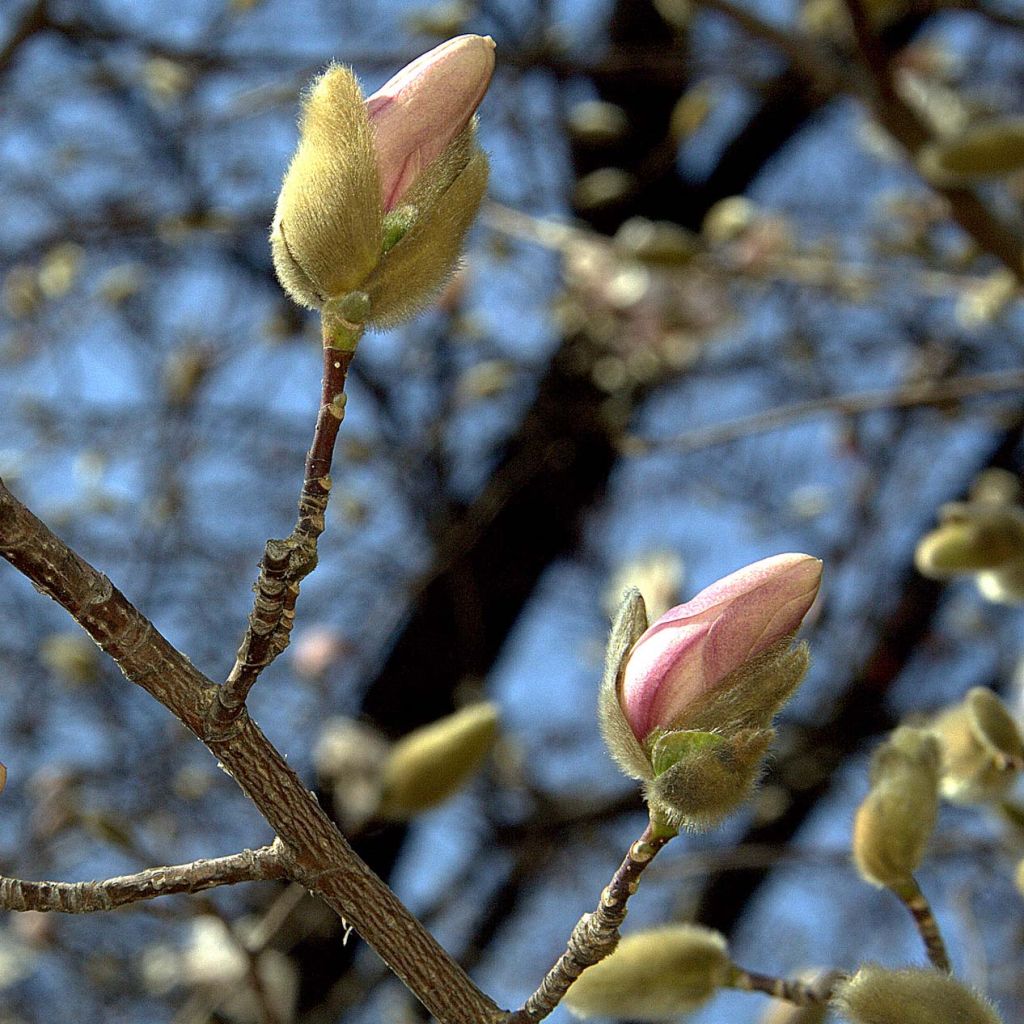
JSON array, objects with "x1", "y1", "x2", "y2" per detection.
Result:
[{"x1": 379, "y1": 701, "x2": 498, "y2": 820}]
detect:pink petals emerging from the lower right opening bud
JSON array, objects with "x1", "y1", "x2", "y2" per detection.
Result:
[{"x1": 618, "y1": 554, "x2": 821, "y2": 742}]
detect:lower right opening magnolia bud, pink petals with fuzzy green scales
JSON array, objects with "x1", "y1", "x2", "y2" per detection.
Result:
[{"x1": 599, "y1": 554, "x2": 821, "y2": 827}]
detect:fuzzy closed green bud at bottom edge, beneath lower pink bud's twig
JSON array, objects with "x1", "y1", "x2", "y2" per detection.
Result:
[{"x1": 563, "y1": 925, "x2": 731, "y2": 1021}]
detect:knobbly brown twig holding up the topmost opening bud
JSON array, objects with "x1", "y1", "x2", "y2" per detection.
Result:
[{"x1": 213, "y1": 319, "x2": 361, "y2": 726}]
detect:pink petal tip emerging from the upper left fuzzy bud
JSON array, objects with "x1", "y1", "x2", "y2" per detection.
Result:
[{"x1": 367, "y1": 36, "x2": 495, "y2": 213}]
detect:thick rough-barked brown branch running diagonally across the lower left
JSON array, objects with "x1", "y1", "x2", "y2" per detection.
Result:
[{"x1": 0, "y1": 480, "x2": 504, "y2": 1024}]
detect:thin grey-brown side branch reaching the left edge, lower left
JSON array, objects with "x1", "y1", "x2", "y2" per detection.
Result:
[{"x1": 0, "y1": 846, "x2": 286, "y2": 913}]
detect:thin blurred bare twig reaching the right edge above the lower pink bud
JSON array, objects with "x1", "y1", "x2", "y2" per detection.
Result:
[{"x1": 621, "y1": 370, "x2": 1024, "y2": 455}]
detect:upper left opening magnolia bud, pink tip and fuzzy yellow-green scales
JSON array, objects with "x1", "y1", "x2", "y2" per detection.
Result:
[{"x1": 270, "y1": 36, "x2": 495, "y2": 327}]
